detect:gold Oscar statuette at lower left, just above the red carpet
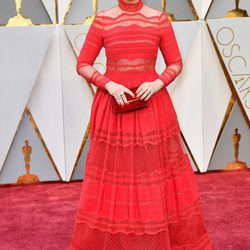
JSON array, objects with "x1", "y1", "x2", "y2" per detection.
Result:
[{"x1": 17, "y1": 140, "x2": 40, "y2": 184}]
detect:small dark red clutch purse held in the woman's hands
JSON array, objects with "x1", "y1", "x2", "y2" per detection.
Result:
[{"x1": 112, "y1": 87, "x2": 148, "y2": 113}]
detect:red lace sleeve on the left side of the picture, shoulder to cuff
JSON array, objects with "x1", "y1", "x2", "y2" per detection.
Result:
[{"x1": 76, "y1": 12, "x2": 110, "y2": 89}]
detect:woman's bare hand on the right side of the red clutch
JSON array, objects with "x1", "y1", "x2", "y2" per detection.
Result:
[{"x1": 135, "y1": 79, "x2": 164, "y2": 101}]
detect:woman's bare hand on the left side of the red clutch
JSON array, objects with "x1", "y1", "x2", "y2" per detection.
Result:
[{"x1": 105, "y1": 81, "x2": 135, "y2": 106}]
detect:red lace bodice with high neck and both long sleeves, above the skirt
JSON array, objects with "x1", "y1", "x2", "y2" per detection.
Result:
[{"x1": 77, "y1": 0, "x2": 183, "y2": 88}]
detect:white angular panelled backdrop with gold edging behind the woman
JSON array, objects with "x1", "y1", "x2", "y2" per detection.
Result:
[{"x1": 0, "y1": 0, "x2": 250, "y2": 184}]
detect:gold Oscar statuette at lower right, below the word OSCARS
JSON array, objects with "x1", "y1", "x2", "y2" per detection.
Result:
[{"x1": 226, "y1": 128, "x2": 247, "y2": 170}]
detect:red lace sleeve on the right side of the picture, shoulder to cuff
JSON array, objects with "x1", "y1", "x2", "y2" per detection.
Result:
[{"x1": 158, "y1": 12, "x2": 183, "y2": 87}]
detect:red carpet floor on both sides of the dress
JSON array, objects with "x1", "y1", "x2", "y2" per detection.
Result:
[{"x1": 0, "y1": 170, "x2": 250, "y2": 250}]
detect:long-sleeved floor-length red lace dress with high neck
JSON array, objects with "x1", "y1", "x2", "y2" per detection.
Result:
[{"x1": 70, "y1": 0, "x2": 212, "y2": 250}]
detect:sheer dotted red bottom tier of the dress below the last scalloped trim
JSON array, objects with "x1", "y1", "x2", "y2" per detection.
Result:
[{"x1": 70, "y1": 223, "x2": 212, "y2": 250}]
